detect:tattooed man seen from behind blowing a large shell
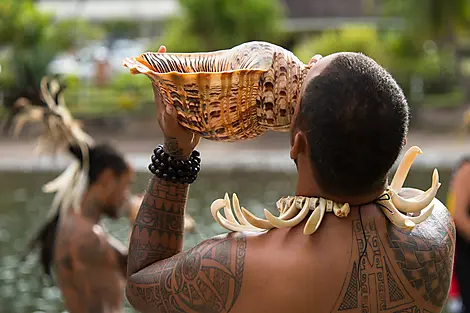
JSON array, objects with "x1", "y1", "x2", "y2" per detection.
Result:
[{"x1": 126, "y1": 47, "x2": 455, "y2": 313}]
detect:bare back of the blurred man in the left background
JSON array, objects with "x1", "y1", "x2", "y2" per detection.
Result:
[{"x1": 55, "y1": 213, "x2": 127, "y2": 313}]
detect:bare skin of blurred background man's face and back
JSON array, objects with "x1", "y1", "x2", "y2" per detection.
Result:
[{"x1": 55, "y1": 163, "x2": 134, "y2": 313}]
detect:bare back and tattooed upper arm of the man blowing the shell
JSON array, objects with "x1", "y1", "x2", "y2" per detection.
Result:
[{"x1": 128, "y1": 186, "x2": 455, "y2": 313}]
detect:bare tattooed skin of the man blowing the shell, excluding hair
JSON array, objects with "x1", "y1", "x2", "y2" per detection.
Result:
[{"x1": 126, "y1": 47, "x2": 455, "y2": 313}]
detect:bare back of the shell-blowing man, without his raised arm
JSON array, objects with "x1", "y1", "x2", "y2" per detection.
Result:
[{"x1": 235, "y1": 194, "x2": 455, "y2": 313}]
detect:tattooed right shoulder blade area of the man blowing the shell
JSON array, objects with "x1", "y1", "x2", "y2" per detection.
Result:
[{"x1": 387, "y1": 191, "x2": 455, "y2": 308}]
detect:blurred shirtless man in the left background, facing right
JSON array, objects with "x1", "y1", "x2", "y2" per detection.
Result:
[{"x1": 26, "y1": 144, "x2": 134, "y2": 313}]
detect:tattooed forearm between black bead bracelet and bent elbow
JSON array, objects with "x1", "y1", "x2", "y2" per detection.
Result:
[{"x1": 127, "y1": 176, "x2": 189, "y2": 275}]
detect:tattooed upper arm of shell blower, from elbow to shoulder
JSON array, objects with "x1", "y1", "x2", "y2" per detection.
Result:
[{"x1": 127, "y1": 233, "x2": 246, "y2": 313}]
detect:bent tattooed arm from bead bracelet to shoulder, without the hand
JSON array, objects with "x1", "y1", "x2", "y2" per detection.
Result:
[{"x1": 126, "y1": 141, "x2": 246, "y2": 313}]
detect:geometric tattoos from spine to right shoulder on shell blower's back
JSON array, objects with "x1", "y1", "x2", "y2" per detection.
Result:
[{"x1": 332, "y1": 204, "x2": 455, "y2": 313}]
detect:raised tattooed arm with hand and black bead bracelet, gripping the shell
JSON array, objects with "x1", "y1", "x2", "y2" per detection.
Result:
[{"x1": 126, "y1": 47, "x2": 250, "y2": 313}]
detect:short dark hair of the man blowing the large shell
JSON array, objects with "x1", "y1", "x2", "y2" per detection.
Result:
[{"x1": 295, "y1": 53, "x2": 409, "y2": 196}]
